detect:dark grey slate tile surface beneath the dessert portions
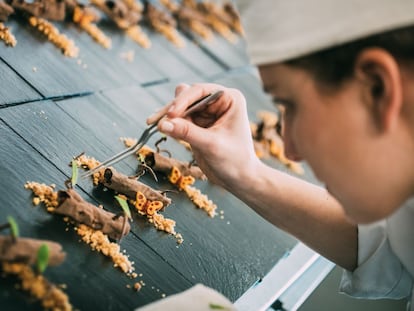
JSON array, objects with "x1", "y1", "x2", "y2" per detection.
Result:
[{"x1": 0, "y1": 8, "x2": 304, "y2": 310}]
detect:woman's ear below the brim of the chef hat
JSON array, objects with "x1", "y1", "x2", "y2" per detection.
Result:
[{"x1": 354, "y1": 48, "x2": 403, "y2": 131}]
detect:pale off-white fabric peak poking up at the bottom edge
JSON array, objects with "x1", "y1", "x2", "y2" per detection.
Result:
[{"x1": 135, "y1": 284, "x2": 236, "y2": 311}]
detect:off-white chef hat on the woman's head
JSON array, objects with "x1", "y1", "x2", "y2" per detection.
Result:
[{"x1": 236, "y1": 0, "x2": 414, "y2": 65}]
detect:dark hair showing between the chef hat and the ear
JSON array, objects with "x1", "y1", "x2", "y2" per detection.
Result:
[{"x1": 285, "y1": 26, "x2": 414, "y2": 86}]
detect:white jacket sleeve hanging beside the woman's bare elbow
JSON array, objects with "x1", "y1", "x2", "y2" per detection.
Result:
[{"x1": 340, "y1": 221, "x2": 412, "y2": 299}]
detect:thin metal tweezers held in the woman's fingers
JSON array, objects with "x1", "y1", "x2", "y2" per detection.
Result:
[{"x1": 80, "y1": 90, "x2": 223, "y2": 178}]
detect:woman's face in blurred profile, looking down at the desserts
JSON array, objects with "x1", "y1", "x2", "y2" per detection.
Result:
[{"x1": 259, "y1": 64, "x2": 408, "y2": 223}]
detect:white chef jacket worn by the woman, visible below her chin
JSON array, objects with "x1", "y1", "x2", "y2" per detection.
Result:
[{"x1": 340, "y1": 198, "x2": 414, "y2": 311}]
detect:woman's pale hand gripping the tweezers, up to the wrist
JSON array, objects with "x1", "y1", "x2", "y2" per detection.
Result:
[{"x1": 147, "y1": 84, "x2": 258, "y2": 188}]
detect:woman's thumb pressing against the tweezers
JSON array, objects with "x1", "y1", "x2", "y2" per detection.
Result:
[{"x1": 158, "y1": 118, "x2": 208, "y2": 146}]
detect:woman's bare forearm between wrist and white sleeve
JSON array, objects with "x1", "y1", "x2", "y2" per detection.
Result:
[{"x1": 227, "y1": 163, "x2": 358, "y2": 271}]
